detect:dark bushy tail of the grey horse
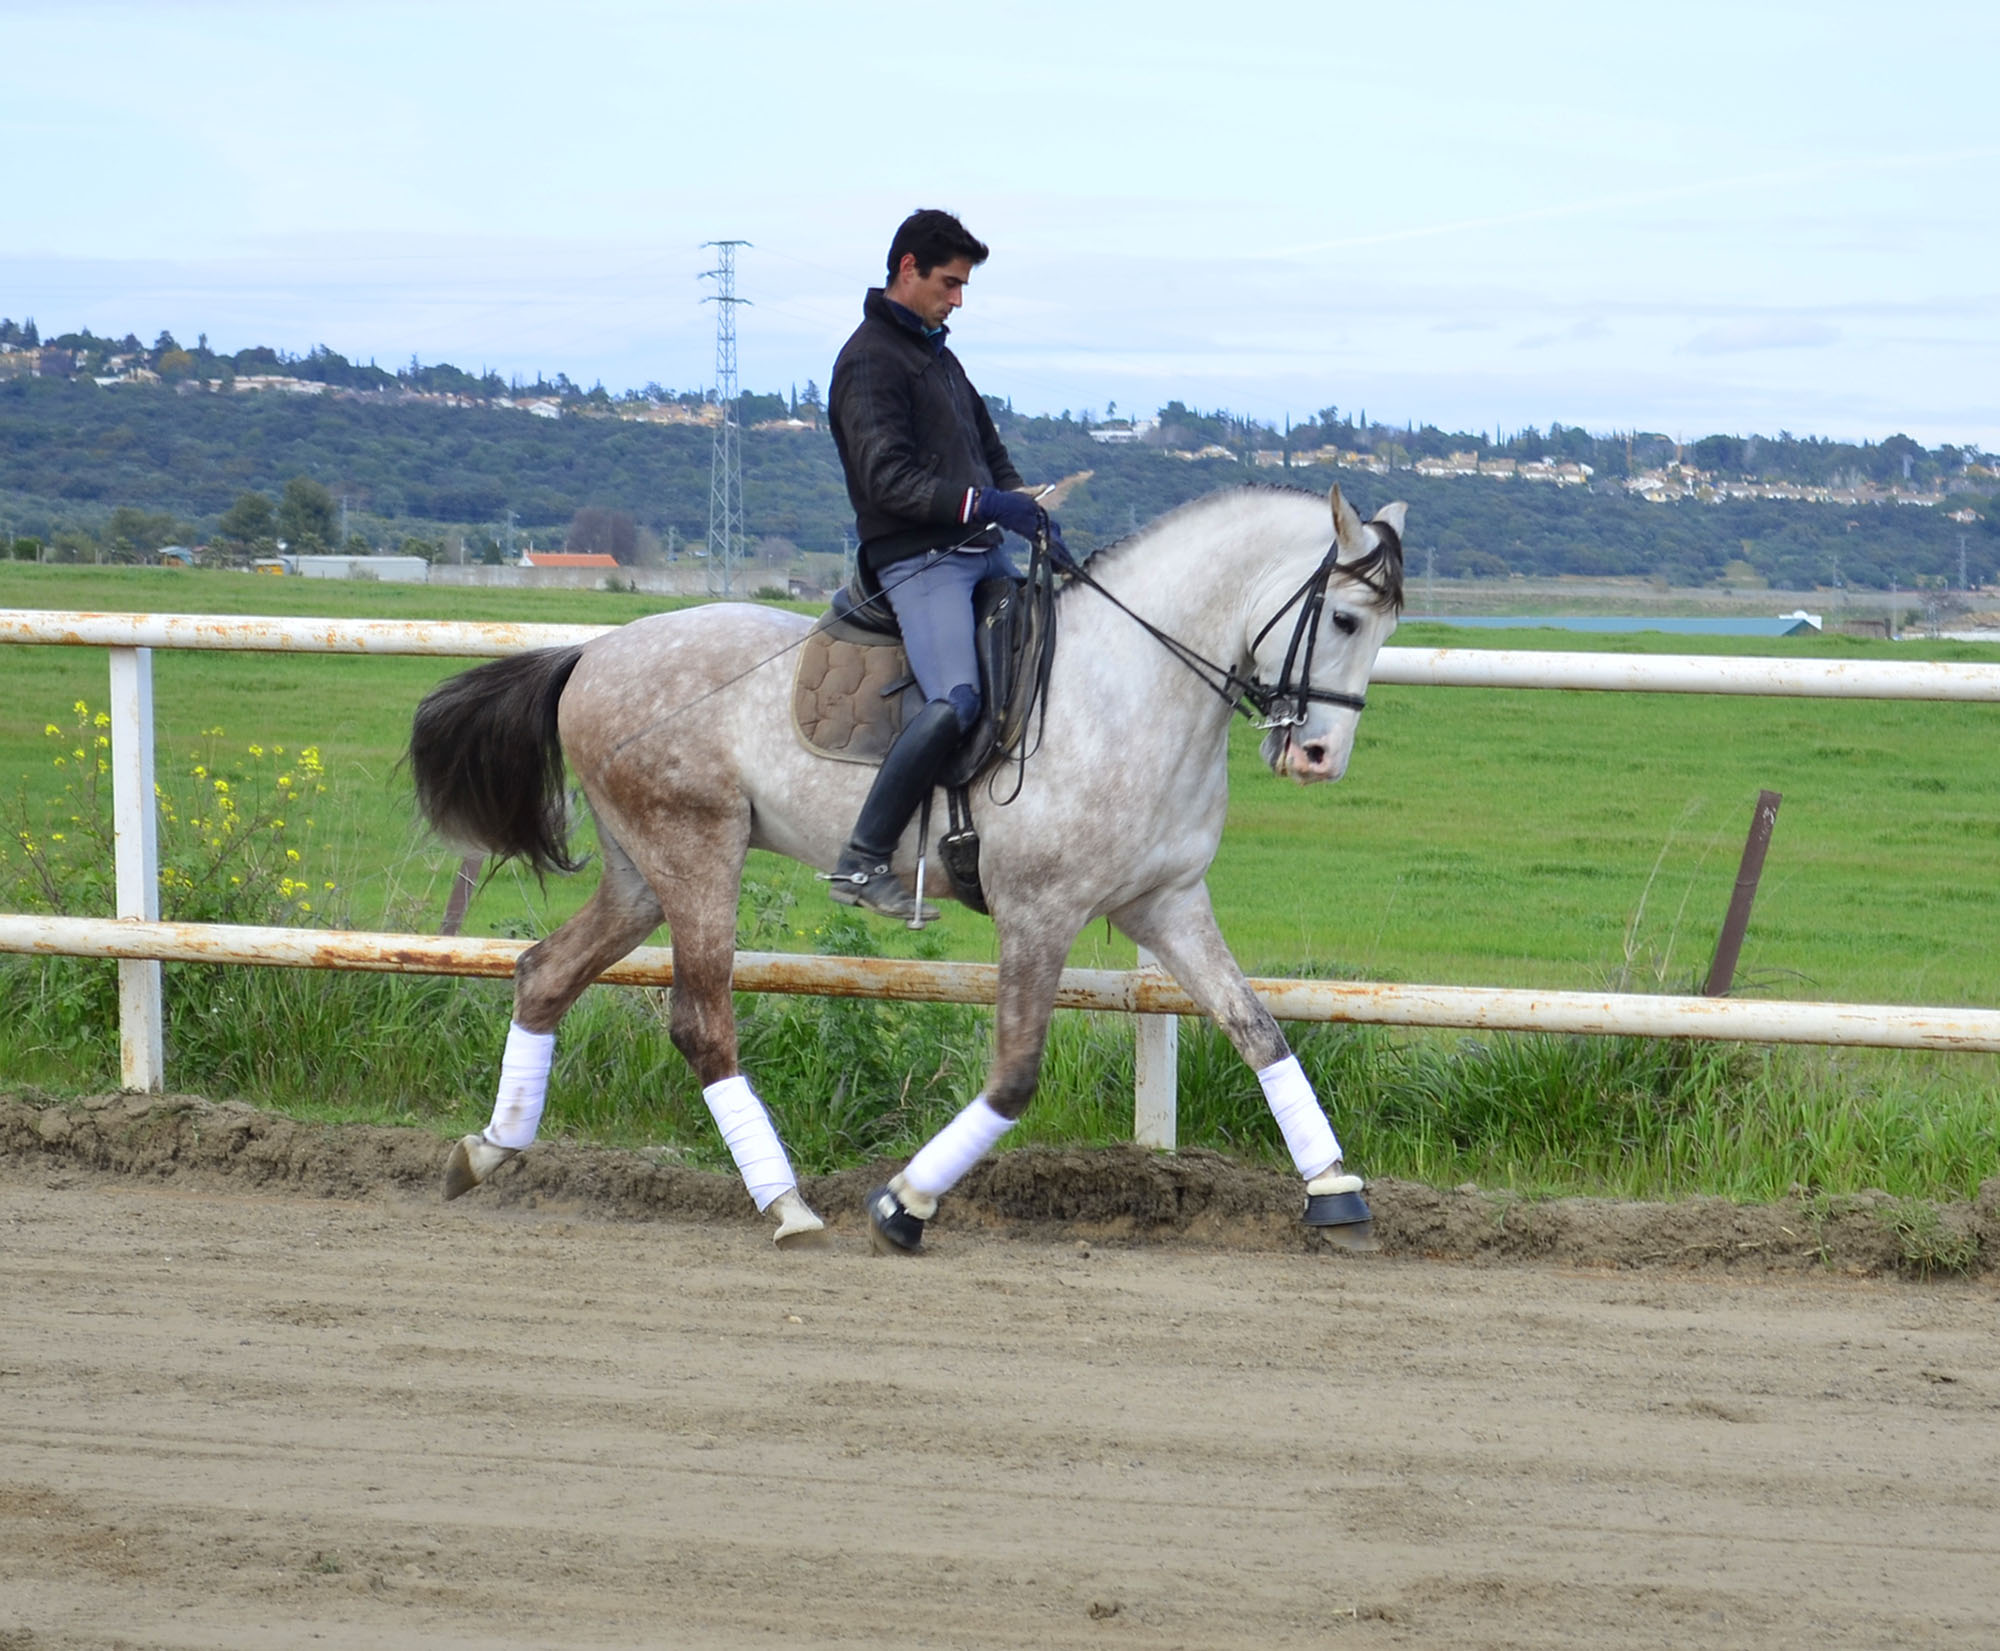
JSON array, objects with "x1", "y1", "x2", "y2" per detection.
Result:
[{"x1": 410, "y1": 646, "x2": 584, "y2": 875}]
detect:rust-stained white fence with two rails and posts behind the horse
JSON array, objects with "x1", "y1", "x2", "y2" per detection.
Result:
[{"x1": 0, "y1": 610, "x2": 2000, "y2": 1147}]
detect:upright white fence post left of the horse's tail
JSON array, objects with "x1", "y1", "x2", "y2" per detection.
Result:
[{"x1": 110, "y1": 648, "x2": 166, "y2": 1091}]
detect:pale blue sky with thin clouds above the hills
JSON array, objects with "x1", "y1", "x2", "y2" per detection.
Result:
[{"x1": 11, "y1": 0, "x2": 2000, "y2": 450}]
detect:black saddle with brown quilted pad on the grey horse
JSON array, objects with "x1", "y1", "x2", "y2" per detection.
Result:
[{"x1": 792, "y1": 574, "x2": 1054, "y2": 911}]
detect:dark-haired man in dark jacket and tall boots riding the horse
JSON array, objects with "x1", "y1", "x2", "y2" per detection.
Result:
[{"x1": 828, "y1": 210, "x2": 1072, "y2": 919}]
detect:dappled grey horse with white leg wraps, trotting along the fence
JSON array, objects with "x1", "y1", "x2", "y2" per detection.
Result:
[{"x1": 410, "y1": 488, "x2": 1404, "y2": 1251}]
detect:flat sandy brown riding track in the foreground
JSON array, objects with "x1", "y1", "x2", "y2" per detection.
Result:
[{"x1": 0, "y1": 1113, "x2": 2000, "y2": 1651}]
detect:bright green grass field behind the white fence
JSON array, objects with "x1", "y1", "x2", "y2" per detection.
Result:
[{"x1": 0, "y1": 566, "x2": 2000, "y2": 1189}]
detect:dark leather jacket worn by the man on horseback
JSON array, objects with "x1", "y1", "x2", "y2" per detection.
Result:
[{"x1": 826, "y1": 288, "x2": 1022, "y2": 572}]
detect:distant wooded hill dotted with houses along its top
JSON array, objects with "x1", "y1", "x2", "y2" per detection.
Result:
[{"x1": 0, "y1": 322, "x2": 2000, "y2": 588}]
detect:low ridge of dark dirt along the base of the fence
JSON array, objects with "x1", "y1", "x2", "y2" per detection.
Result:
[{"x1": 0, "y1": 1095, "x2": 2000, "y2": 1275}]
